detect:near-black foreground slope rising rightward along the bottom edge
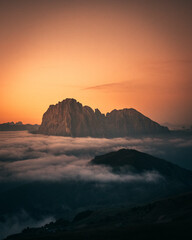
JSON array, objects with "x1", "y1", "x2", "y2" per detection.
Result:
[{"x1": 6, "y1": 190, "x2": 192, "y2": 240}]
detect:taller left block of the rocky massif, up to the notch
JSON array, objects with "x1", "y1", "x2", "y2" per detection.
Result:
[{"x1": 39, "y1": 99, "x2": 104, "y2": 137}]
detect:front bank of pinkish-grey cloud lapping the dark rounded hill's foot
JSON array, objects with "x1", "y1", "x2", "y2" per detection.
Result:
[{"x1": 1, "y1": 154, "x2": 161, "y2": 182}]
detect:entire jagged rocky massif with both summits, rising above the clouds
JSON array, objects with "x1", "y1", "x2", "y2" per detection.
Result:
[{"x1": 39, "y1": 98, "x2": 168, "y2": 138}]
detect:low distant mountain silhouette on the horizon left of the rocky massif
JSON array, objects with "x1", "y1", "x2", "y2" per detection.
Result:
[{"x1": 0, "y1": 122, "x2": 39, "y2": 131}]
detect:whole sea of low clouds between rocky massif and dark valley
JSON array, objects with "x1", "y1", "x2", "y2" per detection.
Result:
[{"x1": 0, "y1": 132, "x2": 192, "y2": 182}]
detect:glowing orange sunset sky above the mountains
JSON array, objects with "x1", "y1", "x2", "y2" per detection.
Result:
[{"x1": 0, "y1": 0, "x2": 192, "y2": 125}]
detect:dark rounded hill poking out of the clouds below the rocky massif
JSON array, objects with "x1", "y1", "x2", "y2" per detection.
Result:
[{"x1": 89, "y1": 148, "x2": 192, "y2": 183}]
